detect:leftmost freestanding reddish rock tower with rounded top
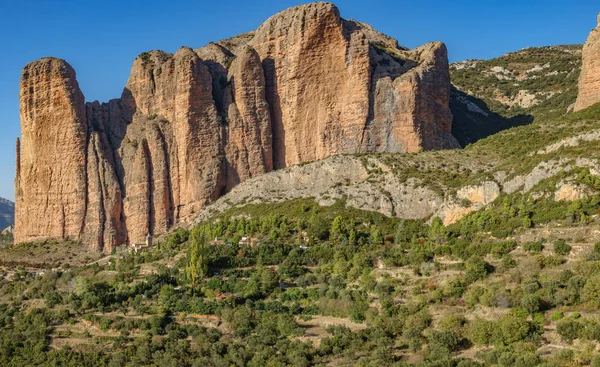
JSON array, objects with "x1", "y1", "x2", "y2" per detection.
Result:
[{"x1": 15, "y1": 58, "x2": 87, "y2": 243}]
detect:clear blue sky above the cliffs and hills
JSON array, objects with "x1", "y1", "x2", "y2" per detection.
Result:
[{"x1": 0, "y1": 0, "x2": 600, "y2": 200}]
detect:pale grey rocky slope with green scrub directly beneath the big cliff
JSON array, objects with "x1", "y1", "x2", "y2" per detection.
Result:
[{"x1": 197, "y1": 105, "x2": 600, "y2": 230}]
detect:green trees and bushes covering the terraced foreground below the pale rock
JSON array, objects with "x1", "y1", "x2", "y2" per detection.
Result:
[{"x1": 0, "y1": 180, "x2": 600, "y2": 366}]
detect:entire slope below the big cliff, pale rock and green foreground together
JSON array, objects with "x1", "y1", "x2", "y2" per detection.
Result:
[{"x1": 0, "y1": 100, "x2": 600, "y2": 367}]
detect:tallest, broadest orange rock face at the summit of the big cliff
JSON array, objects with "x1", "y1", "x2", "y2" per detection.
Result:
[{"x1": 250, "y1": 3, "x2": 371, "y2": 168}]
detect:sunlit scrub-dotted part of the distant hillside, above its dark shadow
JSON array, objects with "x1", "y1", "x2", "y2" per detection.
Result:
[{"x1": 451, "y1": 45, "x2": 581, "y2": 118}]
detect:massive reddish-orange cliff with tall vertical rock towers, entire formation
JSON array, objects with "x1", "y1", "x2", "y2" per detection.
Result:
[{"x1": 15, "y1": 3, "x2": 458, "y2": 251}]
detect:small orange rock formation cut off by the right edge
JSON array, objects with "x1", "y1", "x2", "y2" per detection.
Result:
[{"x1": 575, "y1": 14, "x2": 600, "y2": 111}]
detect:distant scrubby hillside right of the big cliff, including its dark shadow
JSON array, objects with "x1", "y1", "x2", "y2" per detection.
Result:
[{"x1": 450, "y1": 45, "x2": 582, "y2": 146}]
